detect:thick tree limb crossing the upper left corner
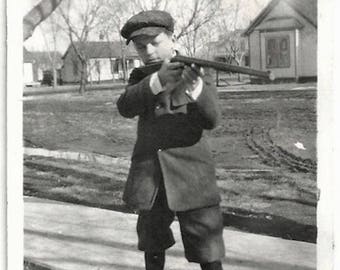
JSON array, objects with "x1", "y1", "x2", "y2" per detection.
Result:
[{"x1": 23, "y1": 0, "x2": 62, "y2": 40}]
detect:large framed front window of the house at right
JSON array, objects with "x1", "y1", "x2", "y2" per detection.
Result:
[{"x1": 265, "y1": 36, "x2": 290, "y2": 68}]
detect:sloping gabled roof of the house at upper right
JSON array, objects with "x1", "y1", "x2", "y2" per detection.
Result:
[{"x1": 243, "y1": 0, "x2": 318, "y2": 36}]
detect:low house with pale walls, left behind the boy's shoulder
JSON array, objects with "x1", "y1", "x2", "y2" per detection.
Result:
[{"x1": 61, "y1": 41, "x2": 141, "y2": 83}]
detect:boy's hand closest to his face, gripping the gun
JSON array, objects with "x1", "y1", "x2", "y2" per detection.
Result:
[{"x1": 158, "y1": 59, "x2": 184, "y2": 86}]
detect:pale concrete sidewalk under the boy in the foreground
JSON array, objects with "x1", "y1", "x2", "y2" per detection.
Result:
[{"x1": 24, "y1": 197, "x2": 316, "y2": 270}]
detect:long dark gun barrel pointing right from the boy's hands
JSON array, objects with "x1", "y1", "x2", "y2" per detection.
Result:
[{"x1": 171, "y1": 55, "x2": 275, "y2": 81}]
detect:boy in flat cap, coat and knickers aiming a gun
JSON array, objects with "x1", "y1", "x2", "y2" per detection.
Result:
[{"x1": 117, "y1": 10, "x2": 224, "y2": 270}]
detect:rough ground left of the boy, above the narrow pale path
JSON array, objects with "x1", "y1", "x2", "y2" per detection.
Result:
[{"x1": 24, "y1": 92, "x2": 136, "y2": 156}]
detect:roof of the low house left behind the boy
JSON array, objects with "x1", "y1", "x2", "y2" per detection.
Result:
[{"x1": 62, "y1": 41, "x2": 138, "y2": 58}]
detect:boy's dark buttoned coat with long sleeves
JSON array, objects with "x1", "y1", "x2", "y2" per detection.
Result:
[{"x1": 117, "y1": 65, "x2": 220, "y2": 211}]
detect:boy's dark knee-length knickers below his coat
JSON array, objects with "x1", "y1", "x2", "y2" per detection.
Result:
[{"x1": 137, "y1": 178, "x2": 224, "y2": 263}]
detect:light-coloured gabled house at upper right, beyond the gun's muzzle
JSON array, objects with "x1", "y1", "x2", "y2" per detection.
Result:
[{"x1": 243, "y1": 0, "x2": 317, "y2": 81}]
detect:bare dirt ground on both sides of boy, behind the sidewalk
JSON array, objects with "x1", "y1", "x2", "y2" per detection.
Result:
[{"x1": 24, "y1": 86, "x2": 317, "y2": 242}]
